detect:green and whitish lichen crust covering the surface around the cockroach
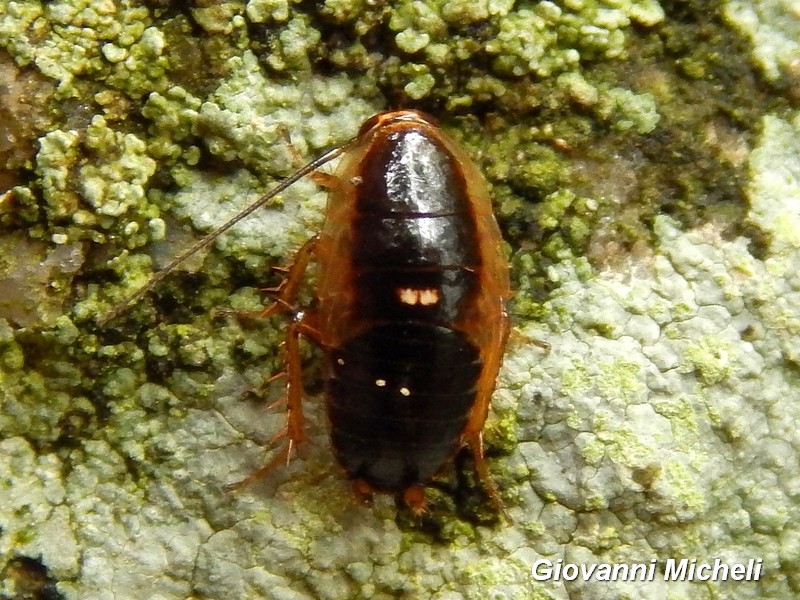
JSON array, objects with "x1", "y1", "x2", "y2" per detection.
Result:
[{"x1": 0, "y1": 0, "x2": 800, "y2": 600}]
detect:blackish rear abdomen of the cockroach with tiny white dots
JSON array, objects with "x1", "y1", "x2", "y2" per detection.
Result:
[{"x1": 328, "y1": 321, "x2": 480, "y2": 491}]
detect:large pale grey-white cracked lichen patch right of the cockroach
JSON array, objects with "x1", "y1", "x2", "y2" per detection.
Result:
[{"x1": 507, "y1": 195, "x2": 800, "y2": 598}]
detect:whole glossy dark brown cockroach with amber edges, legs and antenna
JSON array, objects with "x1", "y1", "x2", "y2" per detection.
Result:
[{"x1": 104, "y1": 110, "x2": 511, "y2": 513}]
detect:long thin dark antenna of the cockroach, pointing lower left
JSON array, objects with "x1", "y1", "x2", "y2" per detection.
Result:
[{"x1": 97, "y1": 140, "x2": 352, "y2": 327}]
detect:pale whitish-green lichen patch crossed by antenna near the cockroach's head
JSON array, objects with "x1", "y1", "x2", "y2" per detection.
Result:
[{"x1": 163, "y1": 52, "x2": 376, "y2": 264}]
